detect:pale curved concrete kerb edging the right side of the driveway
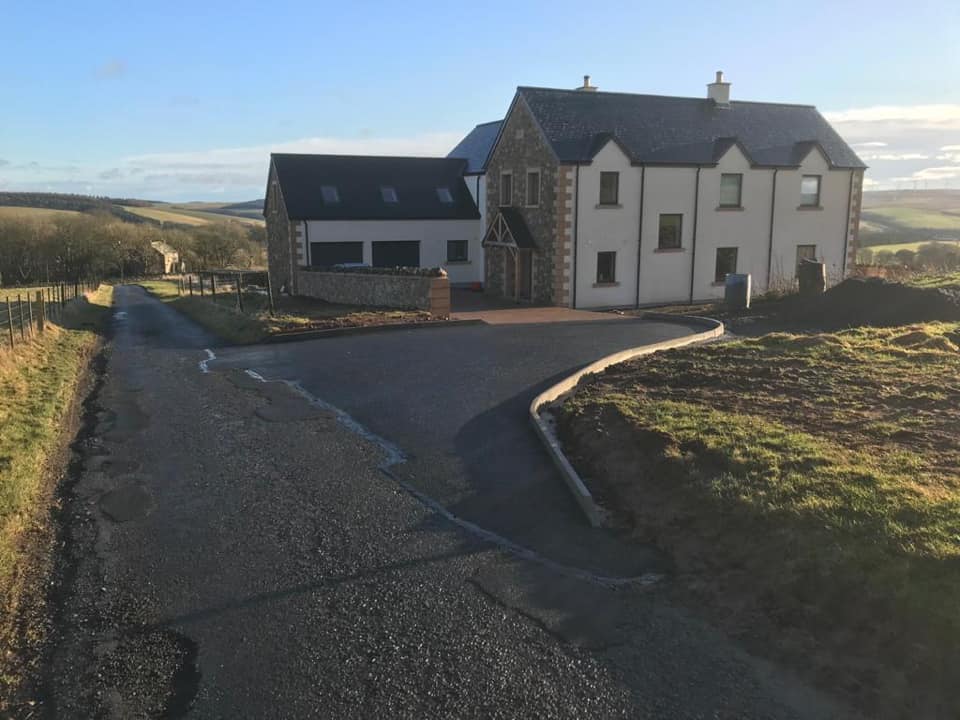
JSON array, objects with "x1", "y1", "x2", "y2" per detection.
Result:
[{"x1": 529, "y1": 312, "x2": 724, "y2": 527}]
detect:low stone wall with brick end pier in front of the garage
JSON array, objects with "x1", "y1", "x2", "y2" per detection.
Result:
[{"x1": 297, "y1": 270, "x2": 450, "y2": 317}]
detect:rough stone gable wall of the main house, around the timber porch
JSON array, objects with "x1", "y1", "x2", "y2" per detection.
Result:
[{"x1": 484, "y1": 99, "x2": 562, "y2": 304}]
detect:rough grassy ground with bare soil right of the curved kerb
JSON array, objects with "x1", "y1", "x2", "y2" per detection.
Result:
[{"x1": 558, "y1": 323, "x2": 960, "y2": 717}]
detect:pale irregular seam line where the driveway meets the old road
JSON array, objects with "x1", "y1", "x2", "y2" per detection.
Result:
[{"x1": 229, "y1": 362, "x2": 663, "y2": 588}]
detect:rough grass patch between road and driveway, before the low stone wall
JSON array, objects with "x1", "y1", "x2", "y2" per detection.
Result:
[{"x1": 140, "y1": 280, "x2": 435, "y2": 344}]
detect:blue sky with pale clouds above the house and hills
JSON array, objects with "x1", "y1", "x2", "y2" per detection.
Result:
[{"x1": 0, "y1": 0, "x2": 960, "y2": 201}]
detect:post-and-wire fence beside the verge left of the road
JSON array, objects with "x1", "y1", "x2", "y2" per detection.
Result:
[{"x1": 0, "y1": 280, "x2": 100, "y2": 351}]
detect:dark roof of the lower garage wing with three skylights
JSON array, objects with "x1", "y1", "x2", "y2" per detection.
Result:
[{"x1": 270, "y1": 153, "x2": 480, "y2": 220}]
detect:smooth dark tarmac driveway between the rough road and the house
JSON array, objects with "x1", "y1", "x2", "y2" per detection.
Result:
[{"x1": 209, "y1": 309, "x2": 694, "y2": 575}]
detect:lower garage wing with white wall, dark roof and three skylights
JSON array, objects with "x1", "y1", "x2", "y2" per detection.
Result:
[{"x1": 264, "y1": 153, "x2": 484, "y2": 294}]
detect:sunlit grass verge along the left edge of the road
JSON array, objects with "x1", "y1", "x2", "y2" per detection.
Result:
[{"x1": 0, "y1": 285, "x2": 112, "y2": 709}]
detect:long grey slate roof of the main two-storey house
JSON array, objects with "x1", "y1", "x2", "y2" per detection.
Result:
[{"x1": 517, "y1": 87, "x2": 866, "y2": 168}]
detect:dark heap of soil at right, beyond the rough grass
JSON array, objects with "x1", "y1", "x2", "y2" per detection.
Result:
[{"x1": 795, "y1": 278, "x2": 960, "y2": 330}]
